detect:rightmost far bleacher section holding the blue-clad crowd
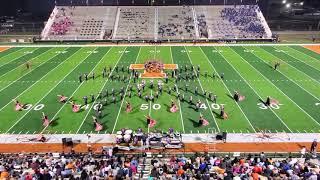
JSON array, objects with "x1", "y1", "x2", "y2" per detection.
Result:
[{"x1": 195, "y1": 6, "x2": 272, "y2": 39}]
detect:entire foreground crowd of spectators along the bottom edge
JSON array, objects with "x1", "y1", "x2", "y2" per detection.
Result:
[{"x1": 0, "y1": 149, "x2": 320, "y2": 180}]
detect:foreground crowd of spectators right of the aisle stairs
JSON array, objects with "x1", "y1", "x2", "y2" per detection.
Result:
[{"x1": 150, "y1": 153, "x2": 320, "y2": 180}]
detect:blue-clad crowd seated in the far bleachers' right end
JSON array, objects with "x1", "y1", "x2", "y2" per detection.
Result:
[{"x1": 221, "y1": 5, "x2": 265, "y2": 36}]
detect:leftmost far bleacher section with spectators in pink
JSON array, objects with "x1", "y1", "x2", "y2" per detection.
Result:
[{"x1": 42, "y1": 6, "x2": 117, "y2": 40}]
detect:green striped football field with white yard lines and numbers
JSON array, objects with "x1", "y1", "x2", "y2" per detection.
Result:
[{"x1": 0, "y1": 45, "x2": 320, "y2": 134}]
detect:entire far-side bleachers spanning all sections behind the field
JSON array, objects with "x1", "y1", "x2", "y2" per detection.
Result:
[{"x1": 41, "y1": 5, "x2": 272, "y2": 41}]
